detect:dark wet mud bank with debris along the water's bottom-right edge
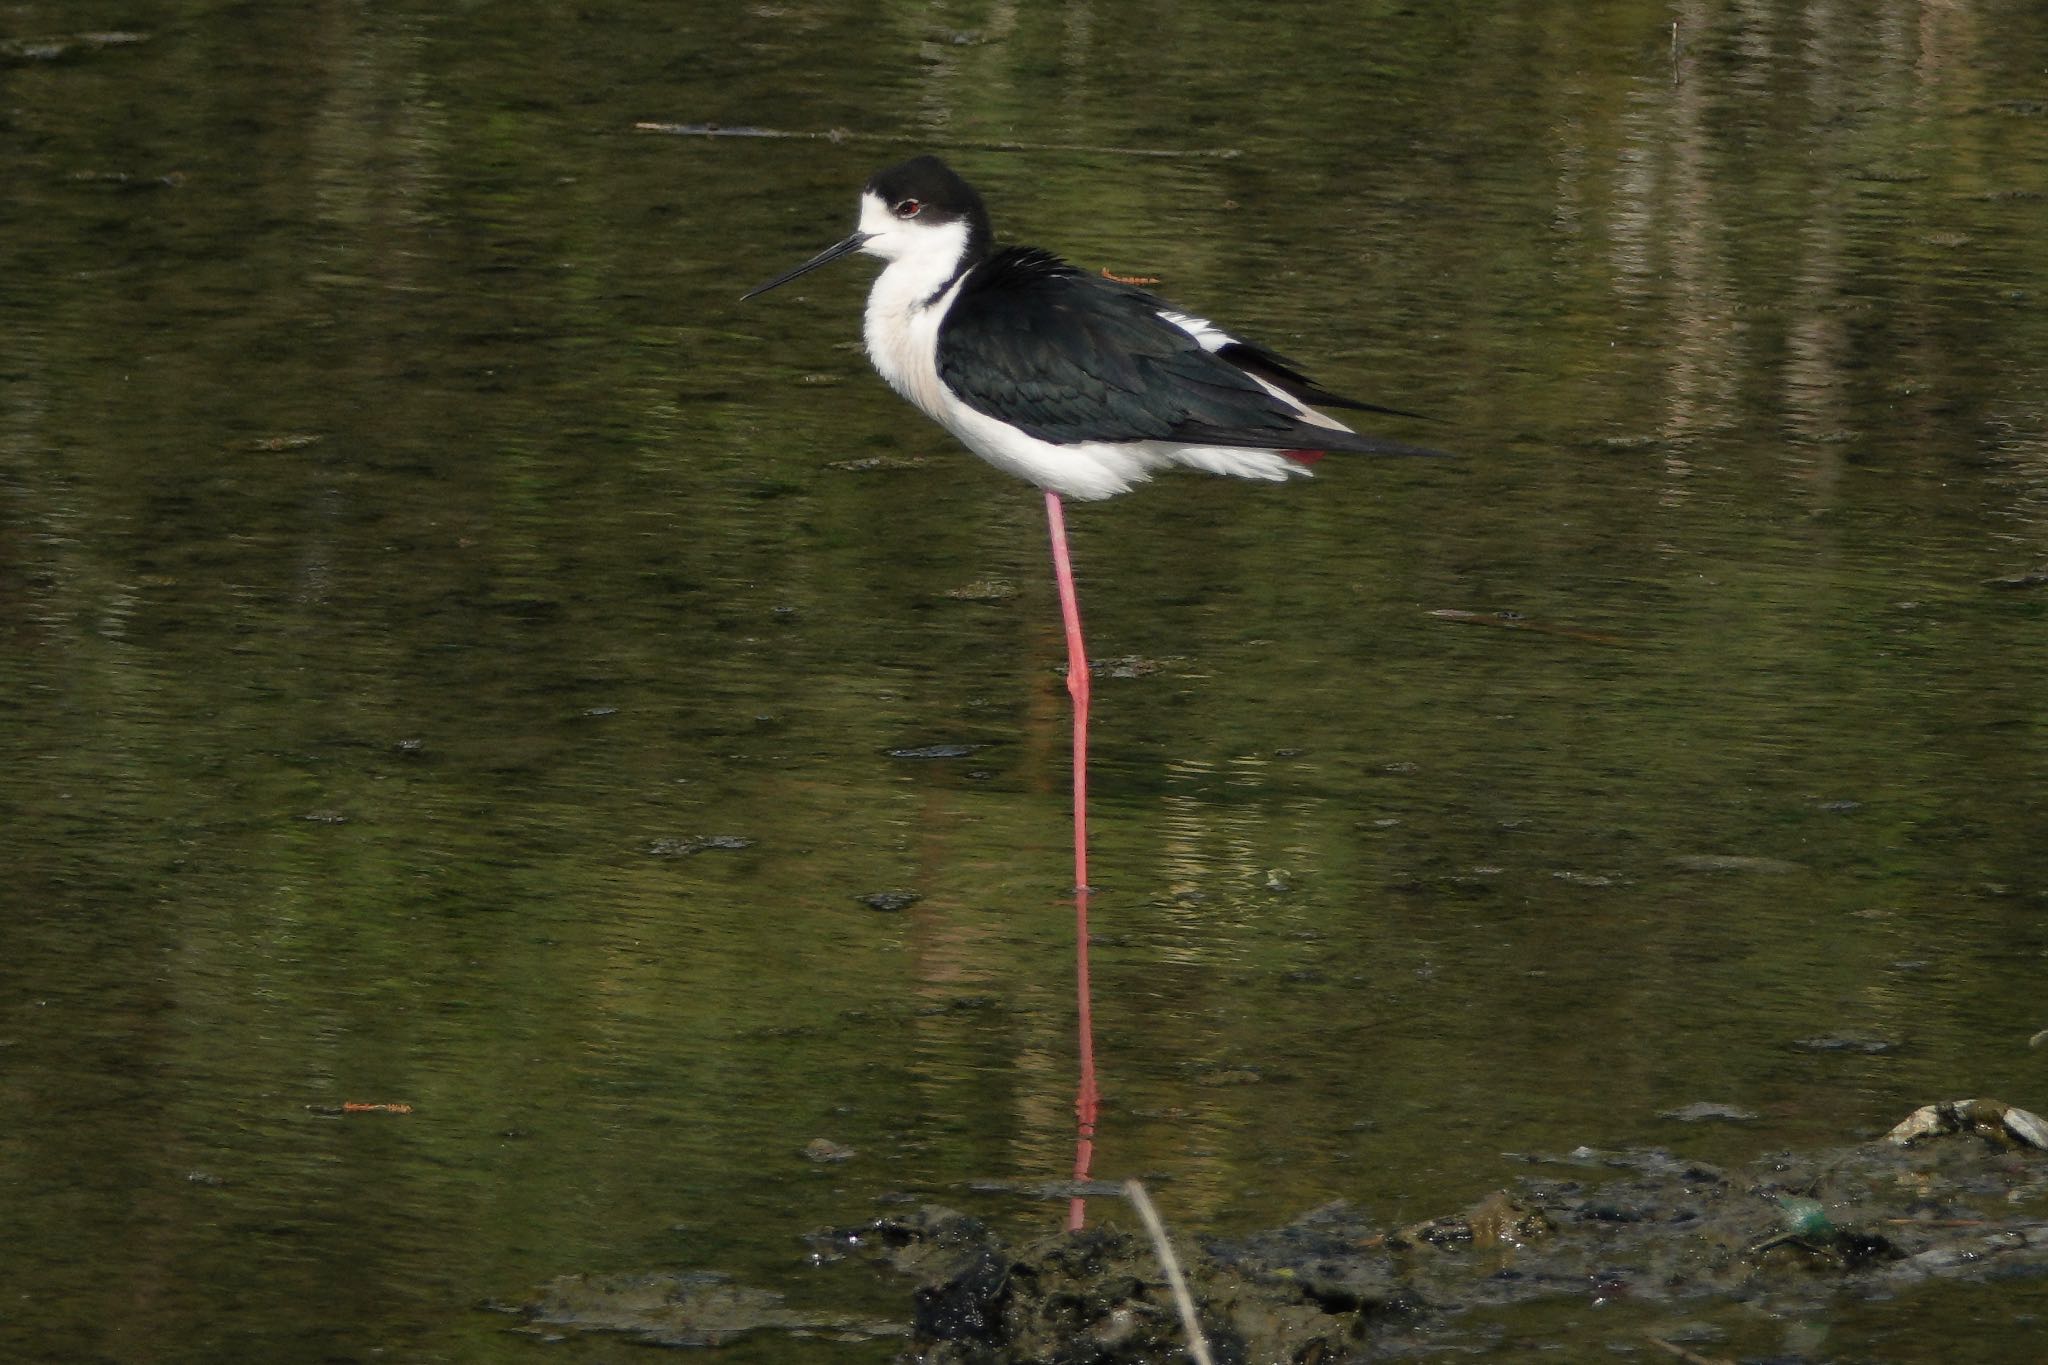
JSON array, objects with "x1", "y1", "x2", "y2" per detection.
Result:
[{"x1": 514, "y1": 1101, "x2": 2048, "y2": 1365}]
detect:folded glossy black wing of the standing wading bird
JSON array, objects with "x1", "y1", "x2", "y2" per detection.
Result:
[{"x1": 938, "y1": 248, "x2": 1436, "y2": 454}]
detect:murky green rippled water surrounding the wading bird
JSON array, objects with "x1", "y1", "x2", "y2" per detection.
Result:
[{"x1": 0, "y1": 0, "x2": 2048, "y2": 1361}]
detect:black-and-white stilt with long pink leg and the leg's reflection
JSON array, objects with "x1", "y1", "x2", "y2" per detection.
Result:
[{"x1": 741, "y1": 156, "x2": 1436, "y2": 1226}]
